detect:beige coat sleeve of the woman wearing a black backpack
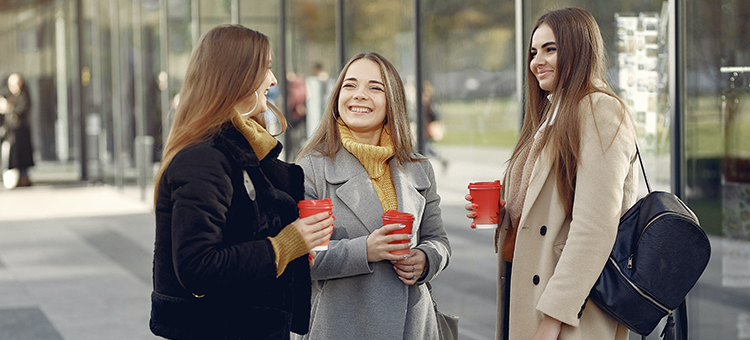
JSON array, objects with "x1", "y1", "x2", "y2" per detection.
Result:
[{"x1": 536, "y1": 94, "x2": 635, "y2": 326}]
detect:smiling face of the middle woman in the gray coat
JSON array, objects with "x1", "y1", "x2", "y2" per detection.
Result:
[{"x1": 338, "y1": 59, "x2": 387, "y2": 145}]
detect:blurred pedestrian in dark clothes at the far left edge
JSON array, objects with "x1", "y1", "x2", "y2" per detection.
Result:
[{"x1": 0, "y1": 73, "x2": 34, "y2": 188}]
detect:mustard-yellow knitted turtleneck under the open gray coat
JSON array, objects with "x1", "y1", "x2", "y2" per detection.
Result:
[{"x1": 339, "y1": 118, "x2": 398, "y2": 211}]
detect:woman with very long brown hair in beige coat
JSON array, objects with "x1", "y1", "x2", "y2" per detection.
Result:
[{"x1": 467, "y1": 8, "x2": 637, "y2": 340}]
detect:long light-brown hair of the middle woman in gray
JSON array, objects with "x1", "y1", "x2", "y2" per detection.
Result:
[{"x1": 297, "y1": 52, "x2": 418, "y2": 164}]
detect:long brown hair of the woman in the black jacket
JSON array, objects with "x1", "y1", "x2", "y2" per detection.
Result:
[{"x1": 154, "y1": 25, "x2": 287, "y2": 203}]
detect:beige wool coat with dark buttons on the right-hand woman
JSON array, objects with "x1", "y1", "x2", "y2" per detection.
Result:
[{"x1": 495, "y1": 93, "x2": 637, "y2": 340}]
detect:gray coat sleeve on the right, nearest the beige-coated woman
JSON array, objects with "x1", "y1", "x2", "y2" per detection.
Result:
[{"x1": 416, "y1": 161, "x2": 451, "y2": 284}]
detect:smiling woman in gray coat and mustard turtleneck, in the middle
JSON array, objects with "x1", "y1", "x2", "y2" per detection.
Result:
[{"x1": 298, "y1": 52, "x2": 450, "y2": 340}]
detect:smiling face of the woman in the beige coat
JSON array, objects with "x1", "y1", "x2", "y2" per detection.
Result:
[{"x1": 529, "y1": 24, "x2": 557, "y2": 92}]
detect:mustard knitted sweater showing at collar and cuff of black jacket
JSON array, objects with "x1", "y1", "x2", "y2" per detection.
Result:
[{"x1": 232, "y1": 112, "x2": 310, "y2": 277}]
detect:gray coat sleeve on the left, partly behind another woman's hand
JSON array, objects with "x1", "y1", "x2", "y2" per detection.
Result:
[{"x1": 299, "y1": 154, "x2": 373, "y2": 280}]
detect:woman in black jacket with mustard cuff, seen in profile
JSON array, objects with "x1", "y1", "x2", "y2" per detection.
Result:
[{"x1": 151, "y1": 25, "x2": 333, "y2": 339}]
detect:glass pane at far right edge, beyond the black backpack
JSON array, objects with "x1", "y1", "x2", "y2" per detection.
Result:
[{"x1": 683, "y1": 0, "x2": 750, "y2": 339}]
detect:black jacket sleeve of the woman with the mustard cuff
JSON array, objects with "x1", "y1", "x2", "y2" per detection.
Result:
[{"x1": 164, "y1": 147, "x2": 276, "y2": 295}]
